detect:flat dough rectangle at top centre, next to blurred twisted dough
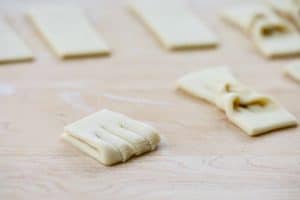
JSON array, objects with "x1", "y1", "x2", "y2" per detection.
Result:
[{"x1": 129, "y1": 0, "x2": 218, "y2": 50}]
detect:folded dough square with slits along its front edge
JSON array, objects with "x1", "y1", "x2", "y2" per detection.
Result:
[{"x1": 62, "y1": 109, "x2": 160, "y2": 165}]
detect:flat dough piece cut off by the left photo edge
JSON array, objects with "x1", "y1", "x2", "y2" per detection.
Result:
[{"x1": 0, "y1": 21, "x2": 33, "y2": 63}]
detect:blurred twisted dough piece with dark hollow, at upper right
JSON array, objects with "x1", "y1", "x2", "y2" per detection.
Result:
[{"x1": 222, "y1": 4, "x2": 300, "y2": 57}]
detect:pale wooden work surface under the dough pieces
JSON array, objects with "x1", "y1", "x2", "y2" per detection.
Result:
[{"x1": 0, "y1": 0, "x2": 300, "y2": 200}]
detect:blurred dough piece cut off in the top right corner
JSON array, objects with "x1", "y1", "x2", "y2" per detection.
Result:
[{"x1": 268, "y1": 0, "x2": 300, "y2": 30}]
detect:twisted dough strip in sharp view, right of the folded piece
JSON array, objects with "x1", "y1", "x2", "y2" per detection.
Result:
[{"x1": 177, "y1": 66, "x2": 297, "y2": 136}]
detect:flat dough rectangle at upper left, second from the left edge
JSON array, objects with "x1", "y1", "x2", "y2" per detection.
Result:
[{"x1": 28, "y1": 6, "x2": 110, "y2": 58}]
